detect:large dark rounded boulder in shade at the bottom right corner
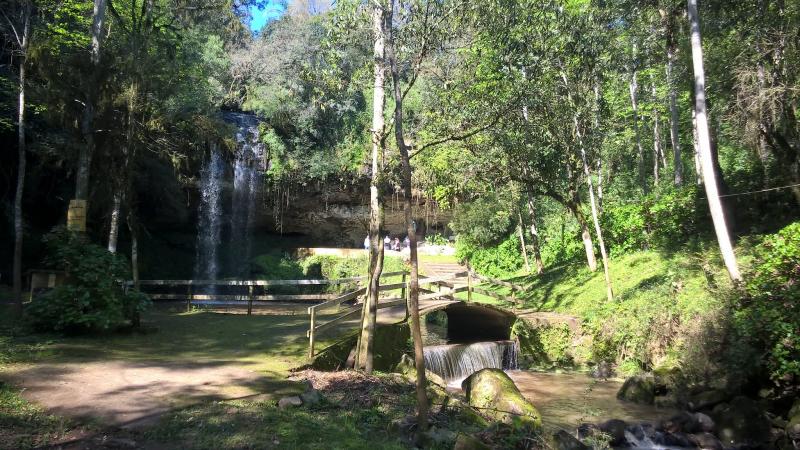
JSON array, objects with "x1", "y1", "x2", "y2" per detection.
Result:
[{"x1": 712, "y1": 396, "x2": 772, "y2": 447}]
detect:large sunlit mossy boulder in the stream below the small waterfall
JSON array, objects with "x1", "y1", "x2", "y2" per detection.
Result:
[{"x1": 462, "y1": 369, "x2": 542, "y2": 429}]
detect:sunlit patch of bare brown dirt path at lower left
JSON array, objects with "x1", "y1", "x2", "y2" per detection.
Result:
[{"x1": 6, "y1": 360, "x2": 298, "y2": 426}]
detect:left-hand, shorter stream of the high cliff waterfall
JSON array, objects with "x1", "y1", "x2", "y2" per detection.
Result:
[{"x1": 194, "y1": 145, "x2": 225, "y2": 280}]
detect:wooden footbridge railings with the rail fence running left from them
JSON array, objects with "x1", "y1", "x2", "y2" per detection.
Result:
[{"x1": 125, "y1": 265, "x2": 577, "y2": 357}]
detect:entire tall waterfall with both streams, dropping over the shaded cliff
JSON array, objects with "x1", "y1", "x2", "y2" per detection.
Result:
[{"x1": 194, "y1": 113, "x2": 266, "y2": 280}]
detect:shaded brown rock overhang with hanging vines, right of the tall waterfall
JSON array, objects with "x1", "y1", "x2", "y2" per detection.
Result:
[{"x1": 254, "y1": 182, "x2": 452, "y2": 247}]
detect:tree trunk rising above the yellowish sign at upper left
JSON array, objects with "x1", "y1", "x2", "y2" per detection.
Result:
[{"x1": 75, "y1": 0, "x2": 106, "y2": 212}]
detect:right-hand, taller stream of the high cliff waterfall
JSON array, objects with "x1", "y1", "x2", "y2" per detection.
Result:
[{"x1": 225, "y1": 113, "x2": 264, "y2": 279}]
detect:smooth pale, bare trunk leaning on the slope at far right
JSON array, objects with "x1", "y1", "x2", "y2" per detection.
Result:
[{"x1": 687, "y1": 0, "x2": 742, "y2": 282}]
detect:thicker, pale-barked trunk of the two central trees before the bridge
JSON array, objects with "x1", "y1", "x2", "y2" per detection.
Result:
[{"x1": 356, "y1": 3, "x2": 386, "y2": 374}]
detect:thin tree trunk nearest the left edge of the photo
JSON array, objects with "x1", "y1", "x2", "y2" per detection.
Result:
[{"x1": 12, "y1": 3, "x2": 31, "y2": 314}]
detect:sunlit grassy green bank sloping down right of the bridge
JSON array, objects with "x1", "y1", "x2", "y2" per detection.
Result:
[{"x1": 462, "y1": 248, "x2": 750, "y2": 375}]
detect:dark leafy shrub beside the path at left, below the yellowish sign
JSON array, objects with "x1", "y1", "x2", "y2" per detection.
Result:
[{"x1": 26, "y1": 228, "x2": 149, "y2": 332}]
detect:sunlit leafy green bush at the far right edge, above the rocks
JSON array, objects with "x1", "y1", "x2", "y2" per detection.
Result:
[{"x1": 734, "y1": 222, "x2": 800, "y2": 382}]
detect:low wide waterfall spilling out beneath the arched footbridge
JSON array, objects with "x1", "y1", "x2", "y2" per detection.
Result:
[{"x1": 424, "y1": 341, "x2": 519, "y2": 385}]
